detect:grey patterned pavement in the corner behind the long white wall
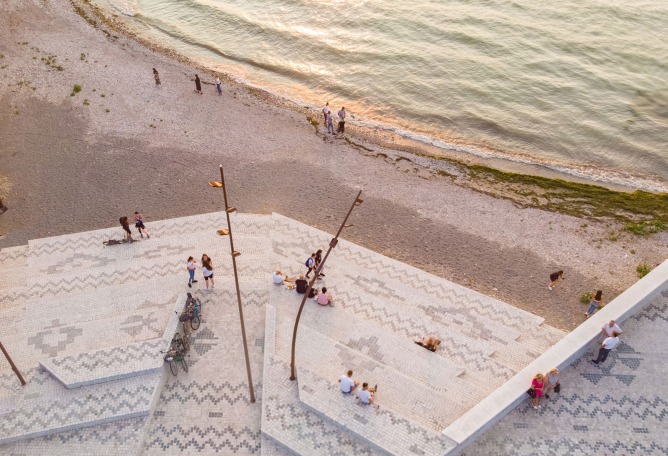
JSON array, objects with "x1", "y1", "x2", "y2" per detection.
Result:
[{"x1": 464, "y1": 291, "x2": 668, "y2": 456}]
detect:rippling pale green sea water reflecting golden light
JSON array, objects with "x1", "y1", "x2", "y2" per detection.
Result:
[{"x1": 108, "y1": 0, "x2": 668, "y2": 190}]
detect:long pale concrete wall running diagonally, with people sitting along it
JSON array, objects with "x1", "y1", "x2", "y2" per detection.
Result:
[{"x1": 443, "y1": 260, "x2": 668, "y2": 455}]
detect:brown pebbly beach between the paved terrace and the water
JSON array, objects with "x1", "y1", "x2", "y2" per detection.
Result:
[{"x1": 0, "y1": 0, "x2": 668, "y2": 330}]
